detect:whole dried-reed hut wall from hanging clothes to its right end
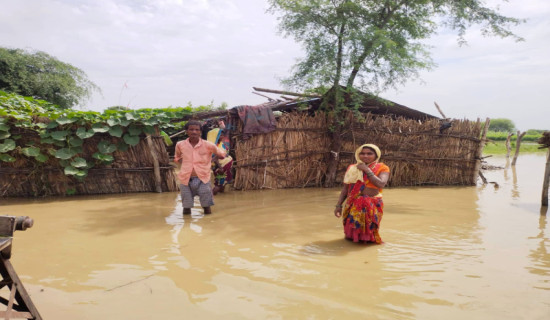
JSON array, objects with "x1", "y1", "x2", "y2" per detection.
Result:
[{"x1": 234, "y1": 112, "x2": 482, "y2": 190}]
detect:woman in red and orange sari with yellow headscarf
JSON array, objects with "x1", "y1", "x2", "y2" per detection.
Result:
[{"x1": 334, "y1": 144, "x2": 390, "y2": 244}]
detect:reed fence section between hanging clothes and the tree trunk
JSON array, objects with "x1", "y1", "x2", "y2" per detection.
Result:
[{"x1": 233, "y1": 112, "x2": 330, "y2": 190}]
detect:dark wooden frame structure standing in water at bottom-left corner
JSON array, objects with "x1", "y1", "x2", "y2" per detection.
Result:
[{"x1": 0, "y1": 216, "x2": 42, "y2": 320}]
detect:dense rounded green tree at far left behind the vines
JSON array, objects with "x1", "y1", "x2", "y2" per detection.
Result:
[{"x1": 0, "y1": 47, "x2": 99, "y2": 108}]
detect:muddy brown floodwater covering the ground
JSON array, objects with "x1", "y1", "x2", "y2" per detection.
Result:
[{"x1": 0, "y1": 153, "x2": 550, "y2": 320}]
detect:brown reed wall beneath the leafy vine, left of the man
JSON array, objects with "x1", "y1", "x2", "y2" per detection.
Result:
[{"x1": 0, "y1": 128, "x2": 178, "y2": 198}]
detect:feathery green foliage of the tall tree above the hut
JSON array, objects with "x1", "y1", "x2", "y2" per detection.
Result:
[{"x1": 269, "y1": 0, "x2": 522, "y2": 93}]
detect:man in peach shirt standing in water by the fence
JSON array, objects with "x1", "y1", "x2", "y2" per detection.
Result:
[{"x1": 174, "y1": 120, "x2": 226, "y2": 214}]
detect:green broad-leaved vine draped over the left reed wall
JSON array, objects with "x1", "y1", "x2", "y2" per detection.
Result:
[{"x1": 0, "y1": 91, "x2": 211, "y2": 179}]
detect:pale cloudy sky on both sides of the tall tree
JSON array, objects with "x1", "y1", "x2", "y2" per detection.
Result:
[{"x1": 0, "y1": 0, "x2": 550, "y2": 130}]
